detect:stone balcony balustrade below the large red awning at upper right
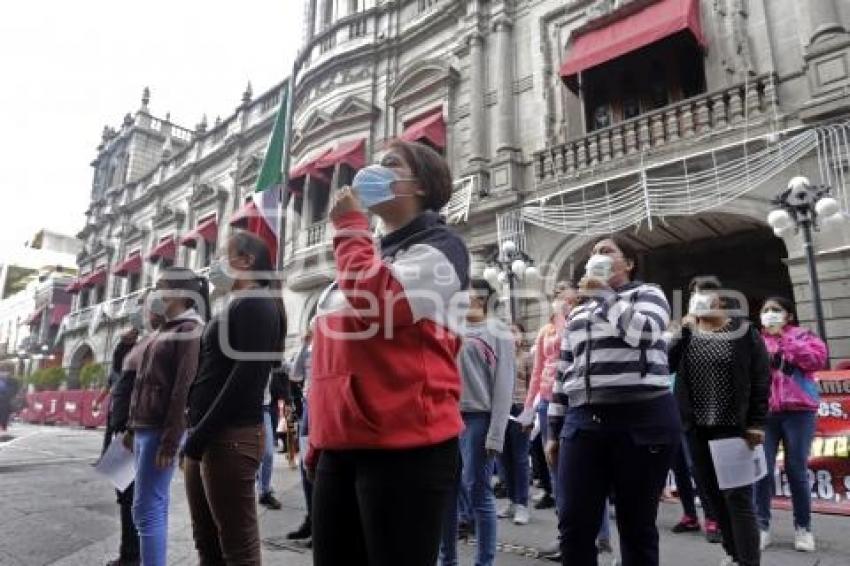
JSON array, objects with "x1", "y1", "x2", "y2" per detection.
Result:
[{"x1": 534, "y1": 75, "x2": 776, "y2": 180}]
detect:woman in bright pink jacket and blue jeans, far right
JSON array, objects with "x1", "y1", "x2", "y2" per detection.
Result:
[{"x1": 756, "y1": 297, "x2": 827, "y2": 552}]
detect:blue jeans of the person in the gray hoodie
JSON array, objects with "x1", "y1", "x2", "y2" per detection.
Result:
[{"x1": 440, "y1": 413, "x2": 497, "y2": 566}]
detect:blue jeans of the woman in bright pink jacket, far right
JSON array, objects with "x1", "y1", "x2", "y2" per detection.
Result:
[{"x1": 756, "y1": 411, "x2": 817, "y2": 530}]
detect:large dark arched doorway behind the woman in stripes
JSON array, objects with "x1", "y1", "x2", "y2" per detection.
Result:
[{"x1": 559, "y1": 213, "x2": 794, "y2": 317}]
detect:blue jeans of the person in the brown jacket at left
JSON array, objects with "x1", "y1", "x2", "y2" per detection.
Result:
[{"x1": 133, "y1": 429, "x2": 177, "y2": 566}]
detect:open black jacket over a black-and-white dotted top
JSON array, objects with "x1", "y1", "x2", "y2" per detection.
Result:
[{"x1": 668, "y1": 321, "x2": 770, "y2": 432}]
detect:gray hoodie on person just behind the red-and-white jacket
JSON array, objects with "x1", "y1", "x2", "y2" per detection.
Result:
[{"x1": 458, "y1": 317, "x2": 516, "y2": 452}]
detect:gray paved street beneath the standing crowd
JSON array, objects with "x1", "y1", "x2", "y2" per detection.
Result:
[{"x1": 0, "y1": 424, "x2": 850, "y2": 566}]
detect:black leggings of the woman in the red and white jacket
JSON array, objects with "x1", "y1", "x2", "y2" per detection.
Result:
[{"x1": 313, "y1": 438, "x2": 459, "y2": 566}]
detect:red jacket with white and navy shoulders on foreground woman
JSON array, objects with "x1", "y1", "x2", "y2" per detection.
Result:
[{"x1": 306, "y1": 212, "x2": 469, "y2": 466}]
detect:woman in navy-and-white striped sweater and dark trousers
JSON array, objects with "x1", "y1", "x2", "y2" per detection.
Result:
[{"x1": 547, "y1": 238, "x2": 681, "y2": 566}]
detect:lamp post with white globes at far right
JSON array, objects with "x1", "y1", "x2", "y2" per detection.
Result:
[{"x1": 767, "y1": 177, "x2": 841, "y2": 342}]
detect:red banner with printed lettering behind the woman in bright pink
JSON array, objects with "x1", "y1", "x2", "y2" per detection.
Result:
[{"x1": 774, "y1": 371, "x2": 850, "y2": 515}]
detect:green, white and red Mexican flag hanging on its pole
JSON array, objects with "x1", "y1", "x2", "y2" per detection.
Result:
[{"x1": 237, "y1": 81, "x2": 292, "y2": 263}]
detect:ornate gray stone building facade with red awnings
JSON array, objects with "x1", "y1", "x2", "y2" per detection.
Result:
[{"x1": 65, "y1": 0, "x2": 850, "y2": 366}]
